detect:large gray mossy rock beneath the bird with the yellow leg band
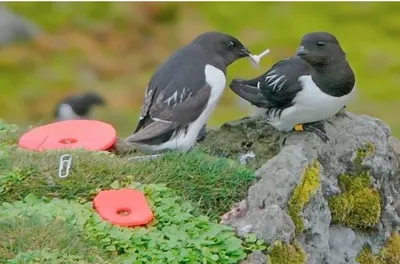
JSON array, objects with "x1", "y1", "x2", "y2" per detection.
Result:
[{"x1": 214, "y1": 112, "x2": 400, "y2": 264}]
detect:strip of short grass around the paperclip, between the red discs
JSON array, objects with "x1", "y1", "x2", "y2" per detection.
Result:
[{"x1": 0, "y1": 120, "x2": 254, "y2": 219}]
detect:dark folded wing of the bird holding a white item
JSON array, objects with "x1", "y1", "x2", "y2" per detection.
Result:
[{"x1": 127, "y1": 48, "x2": 211, "y2": 142}]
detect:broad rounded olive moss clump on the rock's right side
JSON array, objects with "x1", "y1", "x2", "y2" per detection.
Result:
[{"x1": 328, "y1": 171, "x2": 381, "y2": 229}]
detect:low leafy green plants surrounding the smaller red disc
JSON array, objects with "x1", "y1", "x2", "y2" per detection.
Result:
[{"x1": 0, "y1": 189, "x2": 246, "y2": 263}]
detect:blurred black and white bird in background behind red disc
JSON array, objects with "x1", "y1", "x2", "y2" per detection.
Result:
[{"x1": 54, "y1": 92, "x2": 106, "y2": 121}]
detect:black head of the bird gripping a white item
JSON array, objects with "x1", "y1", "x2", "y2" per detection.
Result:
[{"x1": 192, "y1": 31, "x2": 250, "y2": 66}]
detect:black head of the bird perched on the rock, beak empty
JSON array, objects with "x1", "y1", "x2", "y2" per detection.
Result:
[{"x1": 297, "y1": 32, "x2": 346, "y2": 65}]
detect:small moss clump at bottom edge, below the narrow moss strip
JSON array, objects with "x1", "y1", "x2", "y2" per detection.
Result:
[{"x1": 268, "y1": 240, "x2": 307, "y2": 264}]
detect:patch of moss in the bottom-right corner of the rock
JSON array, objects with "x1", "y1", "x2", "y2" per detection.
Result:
[{"x1": 356, "y1": 232, "x2": 400, "y2": 264}]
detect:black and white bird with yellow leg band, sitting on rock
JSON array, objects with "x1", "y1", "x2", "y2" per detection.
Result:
[{"x1": 229, "y1": 32, "x2": 356, "y2": 142}]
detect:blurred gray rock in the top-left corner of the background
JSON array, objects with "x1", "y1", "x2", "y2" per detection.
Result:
[{"x1": 0, "y1": 5, "x2": 41, "y2": 47}]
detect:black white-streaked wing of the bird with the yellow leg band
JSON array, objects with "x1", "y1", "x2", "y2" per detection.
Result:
[{"x1": 229, "y1": 57, "x2": 311, "y2": 109}]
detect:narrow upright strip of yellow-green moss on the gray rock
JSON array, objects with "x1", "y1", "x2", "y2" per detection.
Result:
[{"x1": 288, "y1": 161, "x2": 321, "y2": 234}]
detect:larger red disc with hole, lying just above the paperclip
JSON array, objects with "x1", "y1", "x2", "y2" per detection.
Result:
[{"x1": 19, "y1": 120, "x2": 117, "y2": 151}]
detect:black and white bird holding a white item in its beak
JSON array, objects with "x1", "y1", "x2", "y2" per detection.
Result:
[{"x1": 126, "y1": 32, "x2": 250, "y2": 152}]
